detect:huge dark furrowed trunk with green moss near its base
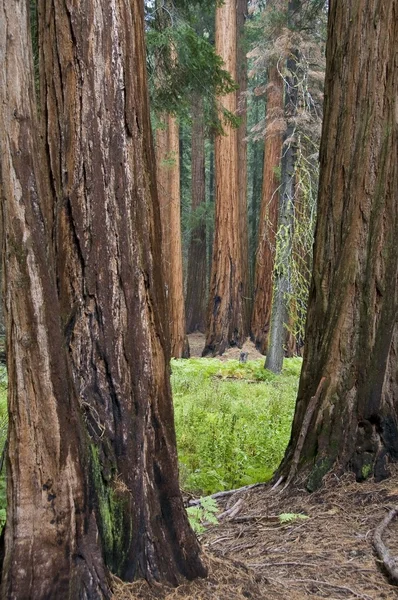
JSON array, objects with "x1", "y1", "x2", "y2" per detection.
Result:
[{"x1": 39, "y1": 0, "x2": 205, "y2": 584}]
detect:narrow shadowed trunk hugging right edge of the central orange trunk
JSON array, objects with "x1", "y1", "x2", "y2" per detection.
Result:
[{"x1": 236, "y1": 0, "x2": 252, "y2": 332}]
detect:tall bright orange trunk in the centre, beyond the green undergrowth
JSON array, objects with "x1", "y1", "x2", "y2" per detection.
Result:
[{"x1": 203, "y1": 0, "x2": 246, "y2": 356}]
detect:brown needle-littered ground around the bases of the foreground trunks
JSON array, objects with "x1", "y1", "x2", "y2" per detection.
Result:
[{"x1": 114, "y1": 336, "x2": 398, "y2": 600}]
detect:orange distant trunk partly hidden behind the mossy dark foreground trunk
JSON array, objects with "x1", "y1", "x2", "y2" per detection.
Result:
[{"x1": 156, "y1": 113, "x2": 189, "y2": 358}]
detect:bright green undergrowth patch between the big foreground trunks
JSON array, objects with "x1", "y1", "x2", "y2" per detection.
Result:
[{"x1": 171, "y1": 358, "x2": 302, "y2": 495}]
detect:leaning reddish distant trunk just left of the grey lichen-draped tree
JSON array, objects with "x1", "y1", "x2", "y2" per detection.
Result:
[{"x1": 251, "y1": 66, "x2": 284, "y2": 354}]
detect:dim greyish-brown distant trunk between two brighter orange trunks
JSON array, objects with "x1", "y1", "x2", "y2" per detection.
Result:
[{"x1": 185, "y1": 96, "x2": 207, "y2": 333}]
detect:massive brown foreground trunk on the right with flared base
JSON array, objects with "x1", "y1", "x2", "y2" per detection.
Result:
[{"x1": 281, "y1": 0, "x2": 398, "y2": 489}]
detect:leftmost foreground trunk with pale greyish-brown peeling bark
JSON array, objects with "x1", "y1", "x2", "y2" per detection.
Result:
[{"x1": 0, "y1": 0, "x2": 110, "y2": 600}]
